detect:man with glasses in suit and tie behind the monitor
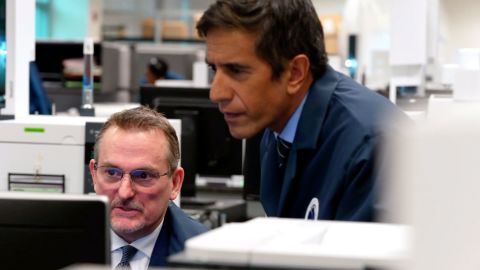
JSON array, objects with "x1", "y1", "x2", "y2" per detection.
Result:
[{"x1": 90, "y1": 107, "x2": 207, "y2": 269}]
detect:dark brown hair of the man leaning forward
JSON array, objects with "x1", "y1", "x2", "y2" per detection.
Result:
[{"x1": 197, "y1": 0, "x2": 328, "y2": 79}]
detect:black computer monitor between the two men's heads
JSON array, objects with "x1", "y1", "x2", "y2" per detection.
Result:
[{"x1": 140, "y1": 86, "x2": 242, "y2": 197}]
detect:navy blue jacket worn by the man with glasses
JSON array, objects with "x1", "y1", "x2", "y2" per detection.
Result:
[{"x1": 150, "y1": 203, "x2": 208, "y2": 266}]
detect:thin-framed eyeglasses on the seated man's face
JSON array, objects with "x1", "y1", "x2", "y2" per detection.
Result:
[{"x1": 94, "y1": 163, "x2": 168, "y2": 187}]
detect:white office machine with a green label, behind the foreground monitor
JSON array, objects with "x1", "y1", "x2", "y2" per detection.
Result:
[{"x1": 0, "y1": 115, "x2": 105, "y2": 194}]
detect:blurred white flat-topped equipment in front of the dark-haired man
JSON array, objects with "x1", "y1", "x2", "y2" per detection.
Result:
[{"x1": 169, "y1": 218, "x2": 412, "y2": 269}]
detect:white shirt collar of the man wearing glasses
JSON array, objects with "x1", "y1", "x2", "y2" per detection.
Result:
[{"x1": 110, "y1": 221, "x2": 163, "y2": 259}]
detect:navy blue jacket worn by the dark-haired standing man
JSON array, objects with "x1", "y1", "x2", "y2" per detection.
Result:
[{"x1": 260, "y1": 67, "x2": 405, "y2": 221}]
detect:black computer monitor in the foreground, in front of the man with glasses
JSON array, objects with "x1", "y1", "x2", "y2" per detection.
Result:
[{"x1": 0, "y1": 192, "x2": 111, "y2": 269}]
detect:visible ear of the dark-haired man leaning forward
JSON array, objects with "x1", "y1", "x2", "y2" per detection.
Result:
[{"x1": 287, "y1": 54, "x2": 310, "y2": 95}]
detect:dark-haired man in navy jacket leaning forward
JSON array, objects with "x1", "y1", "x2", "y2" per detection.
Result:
[{"x1": 197, "y1": 0, "x2": 403, "y2": 221}]
